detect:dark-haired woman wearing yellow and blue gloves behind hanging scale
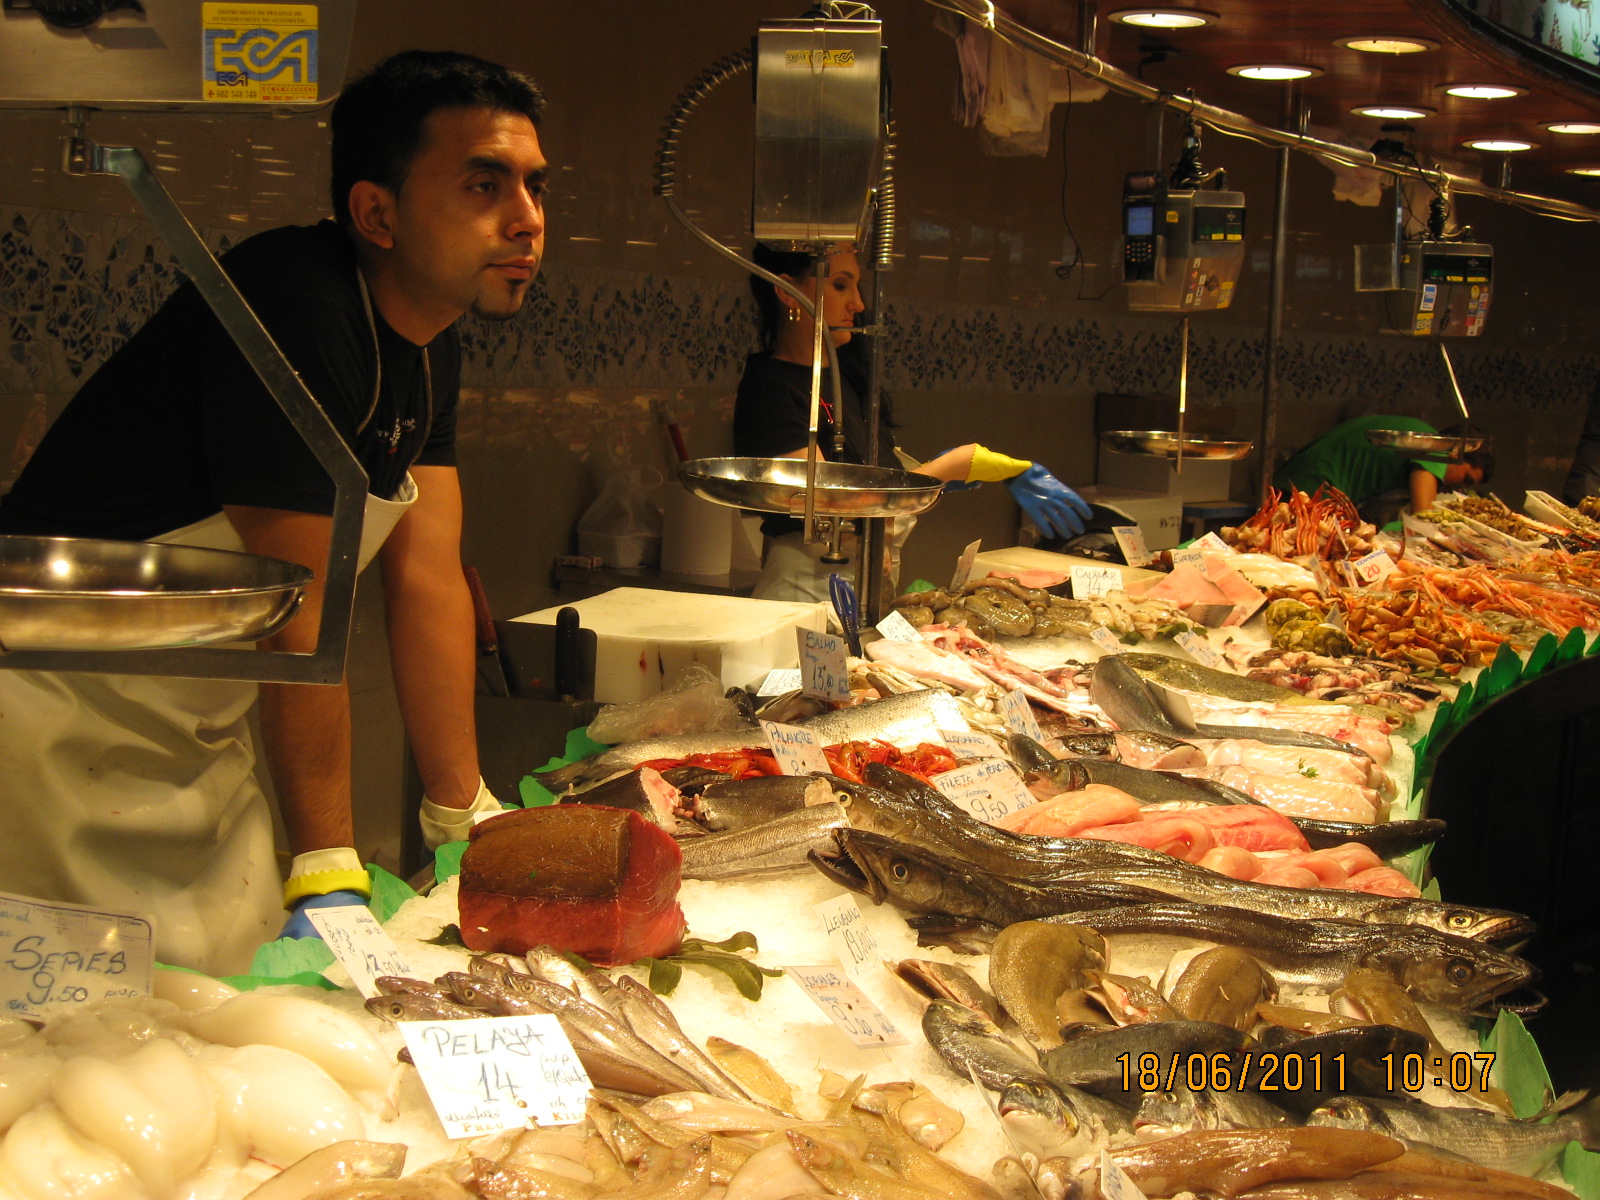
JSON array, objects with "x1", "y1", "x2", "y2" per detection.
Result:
[{"x1": 733, "y1": 243, "x2": 1090, "y2": 600}]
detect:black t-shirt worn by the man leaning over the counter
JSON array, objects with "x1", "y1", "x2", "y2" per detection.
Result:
[{"x1": 0, "y1": 221, "x2": 461, "y2": 539}]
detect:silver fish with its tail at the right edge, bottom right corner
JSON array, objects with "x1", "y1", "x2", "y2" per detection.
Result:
[{"x1": 1306, "y1": 1094, "x2": 1600, "y2": 1174}]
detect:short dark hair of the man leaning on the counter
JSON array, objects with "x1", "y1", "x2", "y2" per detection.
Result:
[{"x1": 331, "y1": 50, "x2": 544, "y2": 224}]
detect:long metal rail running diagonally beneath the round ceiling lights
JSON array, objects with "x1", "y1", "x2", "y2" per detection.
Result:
[{"x1": 928, "y1": 0, "x2": 1600, "y2": 221}]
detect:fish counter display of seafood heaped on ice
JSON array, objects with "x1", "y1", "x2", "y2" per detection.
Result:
[{"x1": 0, "y1": 483, "x2": 1600, "y2": 1200}]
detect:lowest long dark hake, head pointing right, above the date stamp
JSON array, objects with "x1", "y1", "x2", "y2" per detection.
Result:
[{"x1": 1048, "y1": 901, "x2": 1538, "y2": 1013}]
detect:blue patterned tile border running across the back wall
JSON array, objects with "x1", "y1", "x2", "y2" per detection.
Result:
[{"x1": 0, "y1": 205, "x2": 1600, "y2": 411}]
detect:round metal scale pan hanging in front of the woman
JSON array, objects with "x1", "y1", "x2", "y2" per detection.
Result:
[{"x1": 678, "y1": 458, "x2": 944, "y2": 517}]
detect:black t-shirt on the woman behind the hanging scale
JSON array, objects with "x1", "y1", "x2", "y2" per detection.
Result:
[{"x1": 733, "y1": 354, "x2": 898, "y2": 538}]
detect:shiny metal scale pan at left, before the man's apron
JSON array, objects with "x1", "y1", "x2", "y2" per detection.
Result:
[{"x1": 0, "y1": 538, "x2": 312, "y2": 651}]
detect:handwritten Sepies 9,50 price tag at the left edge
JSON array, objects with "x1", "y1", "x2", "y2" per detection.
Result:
[{"x1": 0, "y1": 893, "x2": 155, "y2": 1016}]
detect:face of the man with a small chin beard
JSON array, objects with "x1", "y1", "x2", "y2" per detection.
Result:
[{"x1": 390, "y1": 109, "x2": 546, "y2": 323}]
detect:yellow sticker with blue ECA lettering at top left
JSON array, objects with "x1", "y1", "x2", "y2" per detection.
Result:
[{"x1": 200, "y1": 5, "x2": 317, "y2": 104}]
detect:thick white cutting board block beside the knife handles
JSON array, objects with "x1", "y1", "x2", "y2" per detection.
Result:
[{"x1": 512, "y1": 587, "x2": 829, "y2": 704}]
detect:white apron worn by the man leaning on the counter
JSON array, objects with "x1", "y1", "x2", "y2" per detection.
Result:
[{"x1": 0, "y1": 475, "x2": 416, "y2": 974}]
